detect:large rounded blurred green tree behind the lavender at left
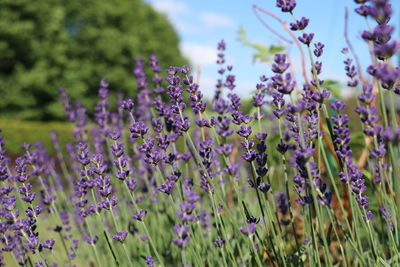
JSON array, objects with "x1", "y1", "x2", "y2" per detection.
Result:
[{"x1": 0, "y1": 0, "x2": 187, "y2": 120}]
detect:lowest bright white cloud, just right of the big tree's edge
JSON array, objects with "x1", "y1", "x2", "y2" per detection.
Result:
[{"x1": 180, "y1": 42, "x2": 217, "y2": 66}]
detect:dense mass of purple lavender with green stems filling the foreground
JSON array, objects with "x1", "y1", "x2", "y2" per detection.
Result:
[{"x1": 0, "y1": 0, "x2": 400, "y2": 267}]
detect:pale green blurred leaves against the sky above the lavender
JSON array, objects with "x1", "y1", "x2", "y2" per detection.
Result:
[{"x1": 238, "y1": 27, "x2": 285, "y2": 62}]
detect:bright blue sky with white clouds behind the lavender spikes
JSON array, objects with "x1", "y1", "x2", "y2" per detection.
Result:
[{"x1": 147, "y1": 0, "x2": 400, "y2": 96}]
